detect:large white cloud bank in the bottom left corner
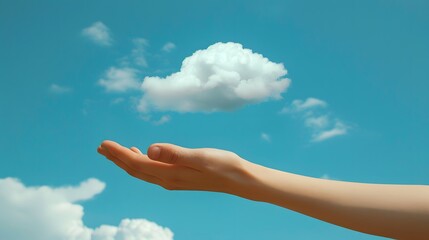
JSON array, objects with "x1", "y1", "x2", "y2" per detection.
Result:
[{"x1": 0, "y1": 178, "x2": 173, "y2": 240}]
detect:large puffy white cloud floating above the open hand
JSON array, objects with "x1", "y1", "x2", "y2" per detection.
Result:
[{"x1": 139, "y1": 42, "x2": 290, "y2": 112}]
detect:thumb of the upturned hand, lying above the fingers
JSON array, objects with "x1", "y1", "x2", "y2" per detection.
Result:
[{"x1": 147, "y1": 143, "x2": 195, "y2": 165}]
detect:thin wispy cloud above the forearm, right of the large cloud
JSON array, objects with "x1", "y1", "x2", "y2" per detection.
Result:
[{"x1": 279, "y1": 98, "x2": 349, "y2": 142}]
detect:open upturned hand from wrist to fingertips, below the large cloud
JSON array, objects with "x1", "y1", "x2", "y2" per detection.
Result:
[{"x1": 97, "y1": 141, "x2": 248, "y2": 194}]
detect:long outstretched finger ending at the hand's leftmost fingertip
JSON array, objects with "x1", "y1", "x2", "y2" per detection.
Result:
[{"x1": 101, "y1": 141, "x2": 171, "y2": 178}]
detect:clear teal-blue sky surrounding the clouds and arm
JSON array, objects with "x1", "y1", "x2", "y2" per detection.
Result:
[{"x1": 0, "y1": 0, "x2": 429, "y2": 240}]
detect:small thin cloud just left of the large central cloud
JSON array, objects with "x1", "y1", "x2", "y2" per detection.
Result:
[{"x1": 98, "y1": 67, "x2": 140, "y2": 92}]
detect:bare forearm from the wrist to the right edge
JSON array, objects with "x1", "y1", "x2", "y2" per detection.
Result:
[{"x1": 236, "y1": 163, "x2": 429, "y2": 239}]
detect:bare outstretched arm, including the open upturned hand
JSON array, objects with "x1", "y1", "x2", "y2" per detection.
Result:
[{"x1": 97, "y1": 141, "x2": 429, "y2": 239}]
